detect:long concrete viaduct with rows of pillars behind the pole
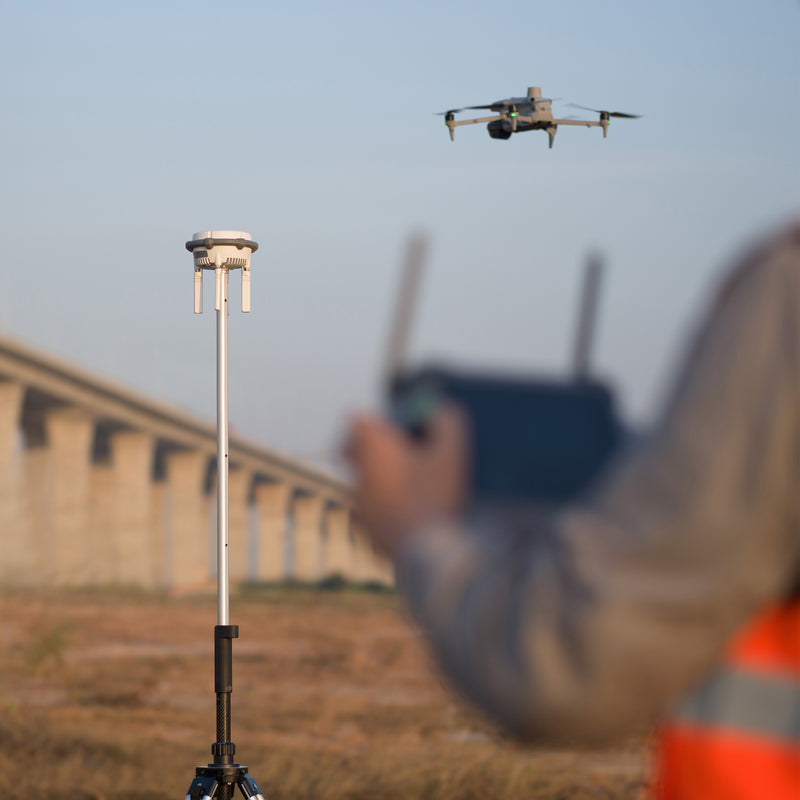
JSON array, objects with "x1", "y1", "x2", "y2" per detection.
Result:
[{"x1": 0, "y1": 337, "x2": 391, "y2": 589}]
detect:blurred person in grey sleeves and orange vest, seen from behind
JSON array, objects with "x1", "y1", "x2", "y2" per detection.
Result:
[{"x1": 347, "y1": 220, "x2": 800, "y2": 800}]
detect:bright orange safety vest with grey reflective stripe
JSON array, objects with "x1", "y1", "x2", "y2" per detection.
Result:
[{"x1": 655, "y1": 597, "x2": 800, "y2": 800}]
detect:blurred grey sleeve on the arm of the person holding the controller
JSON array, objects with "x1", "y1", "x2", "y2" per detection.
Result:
[{"x1": 396, "y1": 223, "x2": 800, "y2": 745}]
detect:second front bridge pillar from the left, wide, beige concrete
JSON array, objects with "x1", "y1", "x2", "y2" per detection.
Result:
[{"x1": 42, "y1": 407, "x2": 95, "y2": 586}]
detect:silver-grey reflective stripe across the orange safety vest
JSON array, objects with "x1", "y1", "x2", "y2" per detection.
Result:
[{"x1": 673, "y1": 669, "x2": 800, "y2": 743}]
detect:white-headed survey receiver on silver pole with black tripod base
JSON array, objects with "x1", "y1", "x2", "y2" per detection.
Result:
[{"x1": 186, "y1": 231, "x2": 264, "y2": 800}]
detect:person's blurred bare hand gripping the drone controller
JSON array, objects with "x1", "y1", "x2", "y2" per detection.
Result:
[{"x1": 345, "y1": 407, "x2": 469, "y2": 558}]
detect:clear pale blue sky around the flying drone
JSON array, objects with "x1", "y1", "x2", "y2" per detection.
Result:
[{"x1": 0, "y1": 0, "x2": 800, "y2": 468}]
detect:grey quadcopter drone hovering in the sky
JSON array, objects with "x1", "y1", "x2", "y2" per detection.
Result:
[{"x1": 440, "y1": 86, "x2": 639, "y2": 147}]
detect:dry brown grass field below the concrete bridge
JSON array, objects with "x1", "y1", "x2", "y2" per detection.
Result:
[{"x1": 0, "y1": 588, "x2": 644, "y2": 800}]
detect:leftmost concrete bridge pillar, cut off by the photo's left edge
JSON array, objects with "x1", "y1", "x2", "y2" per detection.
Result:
[{"x1": 0, "y1": 381, "x2": 25, "y2": 586}]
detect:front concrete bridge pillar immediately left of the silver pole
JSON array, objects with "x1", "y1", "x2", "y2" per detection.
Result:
[{"x1": 163, "y1": 450, "x2": 210, "y2": 587}]
